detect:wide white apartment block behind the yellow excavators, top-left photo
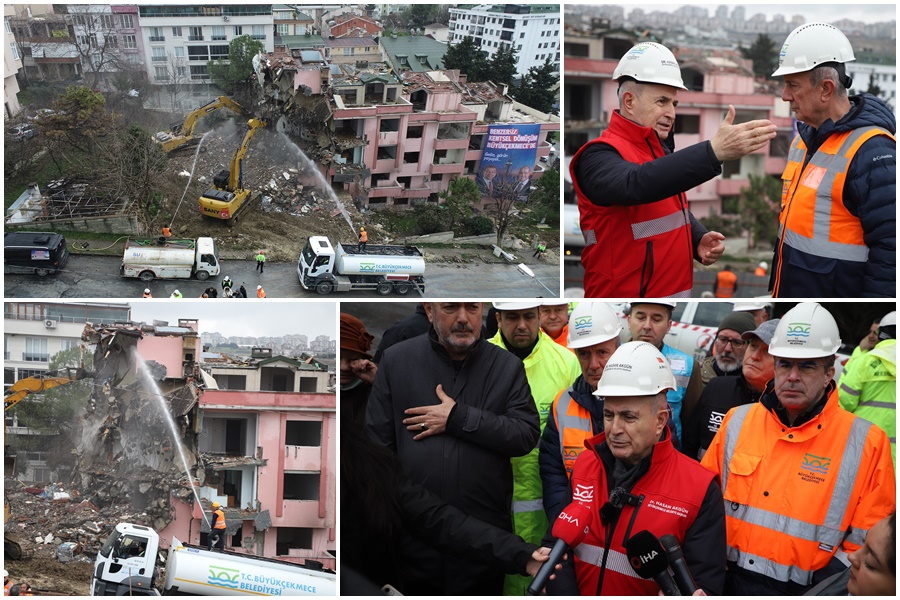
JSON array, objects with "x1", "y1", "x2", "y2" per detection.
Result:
[{"x1": 138, "y1": 4, "x2": 275, "y2": 108}]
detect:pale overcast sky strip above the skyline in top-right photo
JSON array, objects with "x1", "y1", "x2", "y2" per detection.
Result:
[{"x1": 616, "y1": 2, "x2": 897, "y2": 23}]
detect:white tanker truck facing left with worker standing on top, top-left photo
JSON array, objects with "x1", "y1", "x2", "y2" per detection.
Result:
[{"x1": 297, "y1": 236, "x2": 425, "y2": 296}]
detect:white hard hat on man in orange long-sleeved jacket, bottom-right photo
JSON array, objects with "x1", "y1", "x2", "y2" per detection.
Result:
[{"x1": 769, "y1": 302, "x2": 841, "y2": 358}]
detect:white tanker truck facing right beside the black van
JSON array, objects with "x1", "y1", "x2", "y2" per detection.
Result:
[{"x1": 119, "y1": 237, "x2": 220, "y2": 281}]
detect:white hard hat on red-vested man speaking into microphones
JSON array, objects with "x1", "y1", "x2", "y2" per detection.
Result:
[{"x1": 594, "y1": 342, "x2": 675, "y2": 398}]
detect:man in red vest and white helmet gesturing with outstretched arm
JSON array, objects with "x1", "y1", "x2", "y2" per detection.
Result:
[{"x1": 570, "y1": 42, "x2": 776, "y2": 298}]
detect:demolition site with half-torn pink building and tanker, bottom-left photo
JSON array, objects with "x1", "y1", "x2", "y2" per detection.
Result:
[{"x1": 4, "y1": 319, "x2": 336, "y2": 596}]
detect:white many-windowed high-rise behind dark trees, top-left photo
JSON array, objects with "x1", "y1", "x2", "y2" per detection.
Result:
[{"x1": 449, "y1": 4, "x2": 562, "y2": 76}]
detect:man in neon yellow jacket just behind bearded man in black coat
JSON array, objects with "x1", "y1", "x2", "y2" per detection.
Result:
[{"x1": 490, "y1": 300, "x2": 581, "y2": 596}]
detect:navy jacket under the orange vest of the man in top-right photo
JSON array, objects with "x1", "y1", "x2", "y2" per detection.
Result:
[{"x1": 769, "y1": 94, "x2": 897, "y2": 298}]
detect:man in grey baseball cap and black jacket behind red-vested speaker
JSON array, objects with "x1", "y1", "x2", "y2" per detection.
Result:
[{"x1": 682, "y1": 319, "x2": 780, "y2": 460}]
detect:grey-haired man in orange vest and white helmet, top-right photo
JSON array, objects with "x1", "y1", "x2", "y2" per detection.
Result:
[{"x1": 769, "y1": 23, "x2": 897, "y2": 298}]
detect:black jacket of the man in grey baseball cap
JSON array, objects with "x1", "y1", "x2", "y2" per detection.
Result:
[{"x1": 681, "y1": 375, "x2": 759, "y2": 460}]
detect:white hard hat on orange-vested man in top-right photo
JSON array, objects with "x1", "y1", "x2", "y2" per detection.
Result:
[{"x1": 772, "y1": 23, "x2": 856, "y2": 77}]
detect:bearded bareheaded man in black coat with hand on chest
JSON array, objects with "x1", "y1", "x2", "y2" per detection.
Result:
[{"x1": 366, "y1": 302, "x2": 536, "y2": 596}]
